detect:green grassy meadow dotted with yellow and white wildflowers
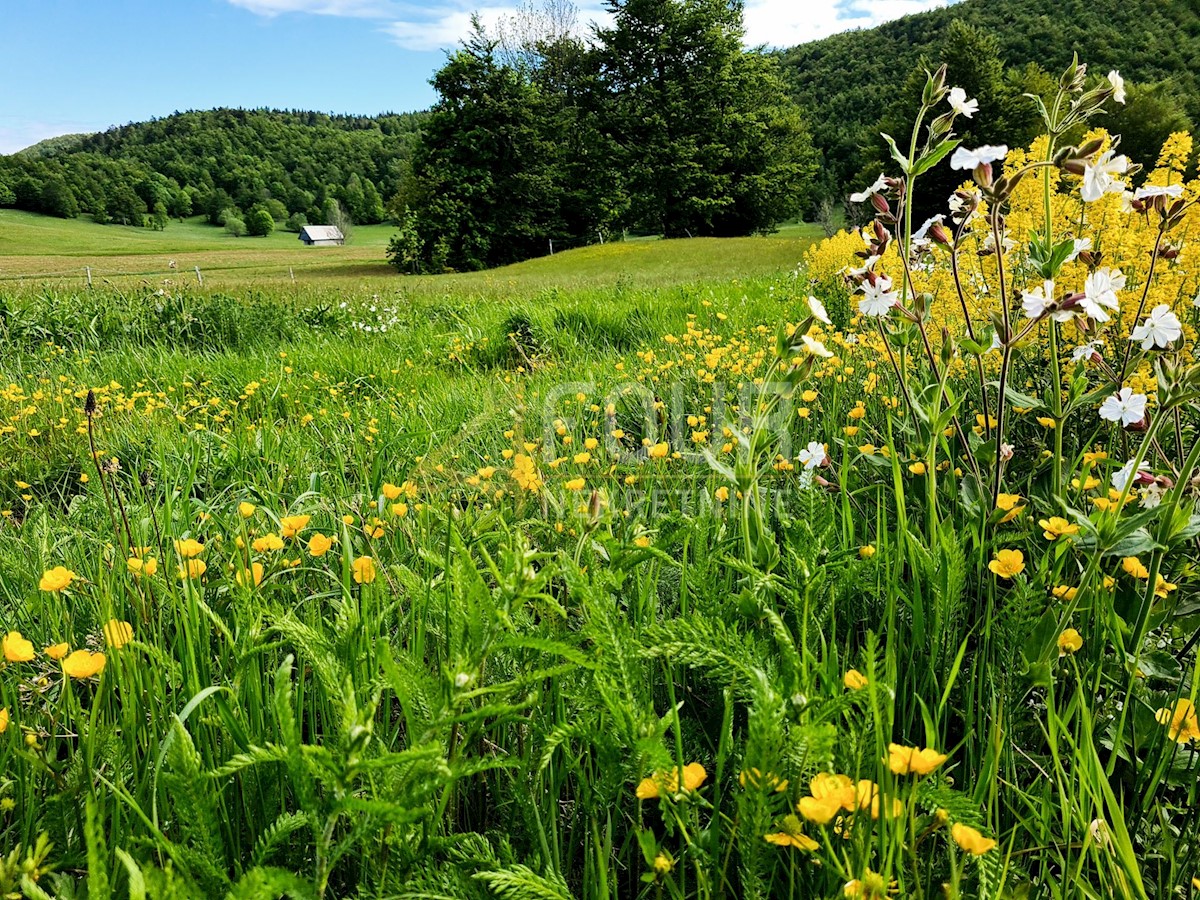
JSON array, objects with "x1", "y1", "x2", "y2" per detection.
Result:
[{"x1": 0, "y1": 102, "x2": 1200, "y2": 900}]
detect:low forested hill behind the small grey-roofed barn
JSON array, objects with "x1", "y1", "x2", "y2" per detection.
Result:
[{"x1": 0, "y1": 109, "x2": 422, "y2": 227}]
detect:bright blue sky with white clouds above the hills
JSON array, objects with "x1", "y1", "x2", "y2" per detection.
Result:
[{"x1": 0, "y1": 0, "x2": 948, "y2": 154}]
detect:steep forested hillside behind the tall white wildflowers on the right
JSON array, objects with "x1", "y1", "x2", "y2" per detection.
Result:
[{"x1": 782, "y1": 0, "x2": 1200, "y2": 200}]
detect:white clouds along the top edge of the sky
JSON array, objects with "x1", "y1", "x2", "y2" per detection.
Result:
[{"x1": 229, "y1": 0, "x2": 953, "y2": 50}]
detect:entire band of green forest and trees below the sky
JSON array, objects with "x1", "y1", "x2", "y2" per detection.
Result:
[{"x1": 0, "y1": 0, "x2": 1200, "y2": 264}]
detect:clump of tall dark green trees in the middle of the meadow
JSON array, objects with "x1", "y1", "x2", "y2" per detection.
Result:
[{"x1": 389, "y1": 0, "x2": 816, "y2": 271}]
